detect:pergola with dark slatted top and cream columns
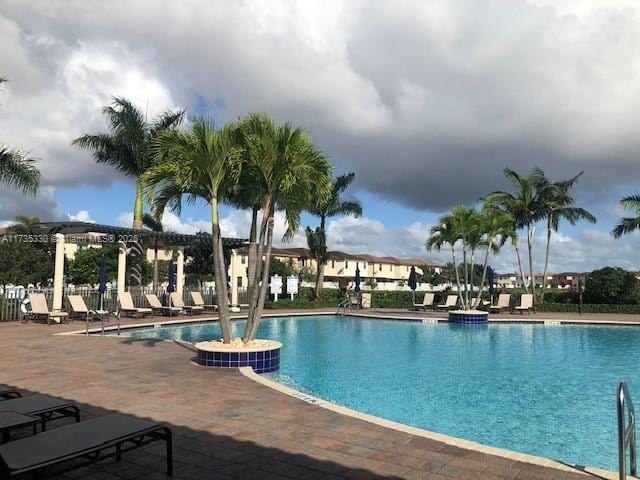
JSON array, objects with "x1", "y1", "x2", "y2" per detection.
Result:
[{"x1": 31, "y1": 222, "x2": 248, "y2": 311}]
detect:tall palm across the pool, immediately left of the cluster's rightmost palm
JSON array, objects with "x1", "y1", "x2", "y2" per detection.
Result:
[{"x1": 484, "y1": 168, "x2": 545, "y2": 301}]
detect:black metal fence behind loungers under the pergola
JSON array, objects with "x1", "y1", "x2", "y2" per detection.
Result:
[{"x1": 0, "y1": 287, "x2": 248, "y2": 322}]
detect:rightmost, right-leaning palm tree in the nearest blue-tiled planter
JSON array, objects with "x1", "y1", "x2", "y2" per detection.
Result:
[{"x1": 242, "y1": 114, "x2": 331, "y2": 343}]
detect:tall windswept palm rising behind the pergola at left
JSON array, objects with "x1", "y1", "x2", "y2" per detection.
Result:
[{"x1": 72, "y1": 97, "x2": 184, "y2": 229}]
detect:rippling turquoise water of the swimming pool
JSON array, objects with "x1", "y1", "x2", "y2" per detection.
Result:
[{"x1": 116, "y1": 316, "x2": 640, "y2": 470}]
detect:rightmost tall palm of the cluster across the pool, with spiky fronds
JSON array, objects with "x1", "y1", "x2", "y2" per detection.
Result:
[{"x1": 531, "y1": 167, "x2": 596, "y2": 301}]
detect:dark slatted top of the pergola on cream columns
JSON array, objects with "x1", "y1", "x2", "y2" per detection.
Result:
[{"x1": 23, "y1": 222, "x2": 248, "y2": 248}]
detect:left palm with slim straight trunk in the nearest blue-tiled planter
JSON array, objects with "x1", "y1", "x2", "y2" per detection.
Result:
[{"x1": 142, "y1": 119, "x2": 243, "y2": 343}]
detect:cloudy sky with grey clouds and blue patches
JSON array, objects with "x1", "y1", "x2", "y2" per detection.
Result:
[{"x1": 0, "y1": 0, "x2": 640, "y2": 271}]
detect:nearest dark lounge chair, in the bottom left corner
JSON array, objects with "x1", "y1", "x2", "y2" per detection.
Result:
[{"x1": 0, "y1": 414, "x2": 173, "y2": 479}]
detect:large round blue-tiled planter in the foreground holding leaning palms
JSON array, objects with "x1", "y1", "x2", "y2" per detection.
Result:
[{"x1": 195, "y1": 340, "x2": 282, "y2": 373}]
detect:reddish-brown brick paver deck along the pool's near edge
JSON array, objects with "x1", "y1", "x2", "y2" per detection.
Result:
[{"x1": 0, "y1": 310, "x2": 624, "y2": 480}]
